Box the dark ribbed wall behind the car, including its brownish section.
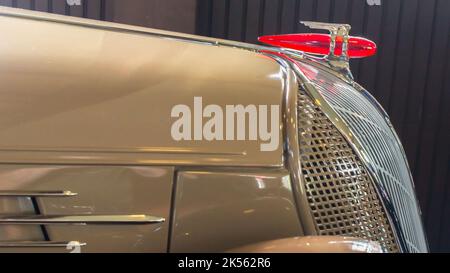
[0,0,450,252]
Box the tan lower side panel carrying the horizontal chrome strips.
[0,165,173,252]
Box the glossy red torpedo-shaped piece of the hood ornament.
[258,33,377,58]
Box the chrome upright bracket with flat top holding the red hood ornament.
[300,21,353,81]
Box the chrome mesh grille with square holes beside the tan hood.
[298,88,399,252]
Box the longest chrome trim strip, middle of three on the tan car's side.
[0,214,165,225]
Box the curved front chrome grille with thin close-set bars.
[301,61,427,252]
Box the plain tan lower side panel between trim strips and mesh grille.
[170,170,302,252]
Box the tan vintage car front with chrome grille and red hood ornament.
[0,8,428,252]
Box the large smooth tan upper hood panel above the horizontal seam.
[0,10,283,166]
